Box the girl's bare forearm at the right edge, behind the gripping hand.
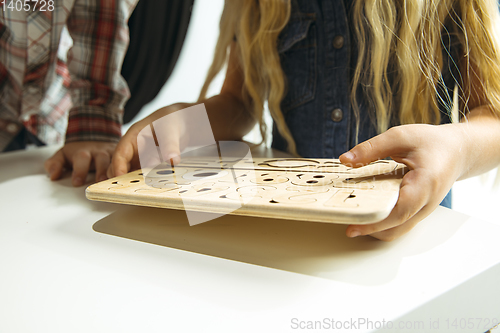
[452,107,500,180]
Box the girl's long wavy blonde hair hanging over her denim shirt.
[200,0,500,154]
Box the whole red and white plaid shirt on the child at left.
[0,0,137,151]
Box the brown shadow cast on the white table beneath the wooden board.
[93,206,468,285]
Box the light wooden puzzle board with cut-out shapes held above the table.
[86,157,405,224]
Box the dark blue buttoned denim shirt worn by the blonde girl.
[272,0,460,207]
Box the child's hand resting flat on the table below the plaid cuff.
[45,141,116,186]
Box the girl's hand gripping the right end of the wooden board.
[340,125,464,241]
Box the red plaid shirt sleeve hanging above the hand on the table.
[66,0,139,142]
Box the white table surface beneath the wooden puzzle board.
[0,147,500,333]
